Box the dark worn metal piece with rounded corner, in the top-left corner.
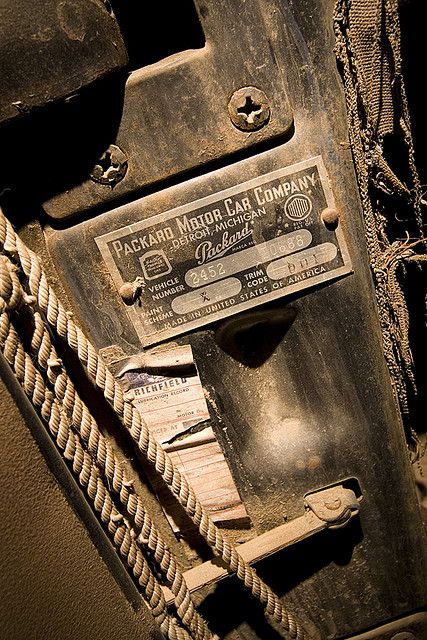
[0,0,127,122]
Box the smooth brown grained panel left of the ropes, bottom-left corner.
[0,361,159,640]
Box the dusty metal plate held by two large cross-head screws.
[40,0,293,218]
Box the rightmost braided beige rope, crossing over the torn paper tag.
[0,211,309,640]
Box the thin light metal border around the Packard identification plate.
[94,156,353,346]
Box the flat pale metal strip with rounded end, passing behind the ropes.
[163,484,361,604]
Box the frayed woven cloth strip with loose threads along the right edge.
[334,0,425,457]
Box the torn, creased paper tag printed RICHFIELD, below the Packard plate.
[114,346,249,532]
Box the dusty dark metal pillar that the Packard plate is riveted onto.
[46,0,425,638]
